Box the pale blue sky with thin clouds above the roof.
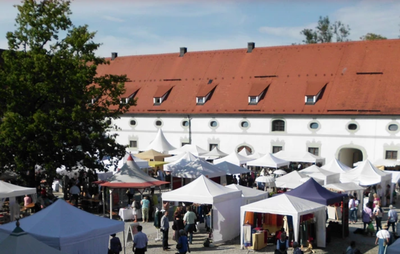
[0,0,400,57]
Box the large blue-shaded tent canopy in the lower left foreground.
[0,199,124,254]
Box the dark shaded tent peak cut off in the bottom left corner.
[0,226,66,254]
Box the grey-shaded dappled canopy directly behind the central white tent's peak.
[170,158,226,178]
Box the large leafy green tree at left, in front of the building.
[0,0,135,186]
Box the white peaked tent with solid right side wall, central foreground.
[161,176,242,242]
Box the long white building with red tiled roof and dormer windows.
[98,40,400,166]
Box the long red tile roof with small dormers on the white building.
[94,40,400,115]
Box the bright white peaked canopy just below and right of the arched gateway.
[340,160,392,187]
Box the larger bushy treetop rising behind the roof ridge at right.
[300,16,350,44]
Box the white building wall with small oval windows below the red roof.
[109,115,400,167]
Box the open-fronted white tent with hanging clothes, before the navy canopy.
[240,194,326,247]
